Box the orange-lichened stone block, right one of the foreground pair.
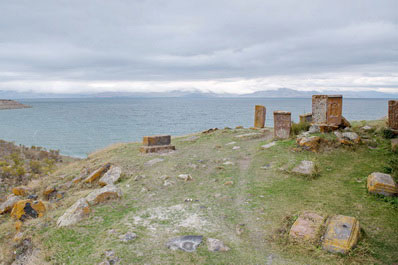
[322,215,360,254]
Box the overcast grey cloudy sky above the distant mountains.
[0,0,398,93]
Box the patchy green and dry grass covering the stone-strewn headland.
[0,122,398,264]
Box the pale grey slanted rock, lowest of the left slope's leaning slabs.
[57,198,90,227]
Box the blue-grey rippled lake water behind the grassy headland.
[0,98,388,157]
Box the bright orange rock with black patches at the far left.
[11,199,46,221]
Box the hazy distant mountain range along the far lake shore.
[0,88,398,99]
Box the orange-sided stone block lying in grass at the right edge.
[367,172,398,196]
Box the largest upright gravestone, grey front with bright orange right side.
[312,95,343,126]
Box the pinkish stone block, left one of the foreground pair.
[289,212,325,243]
